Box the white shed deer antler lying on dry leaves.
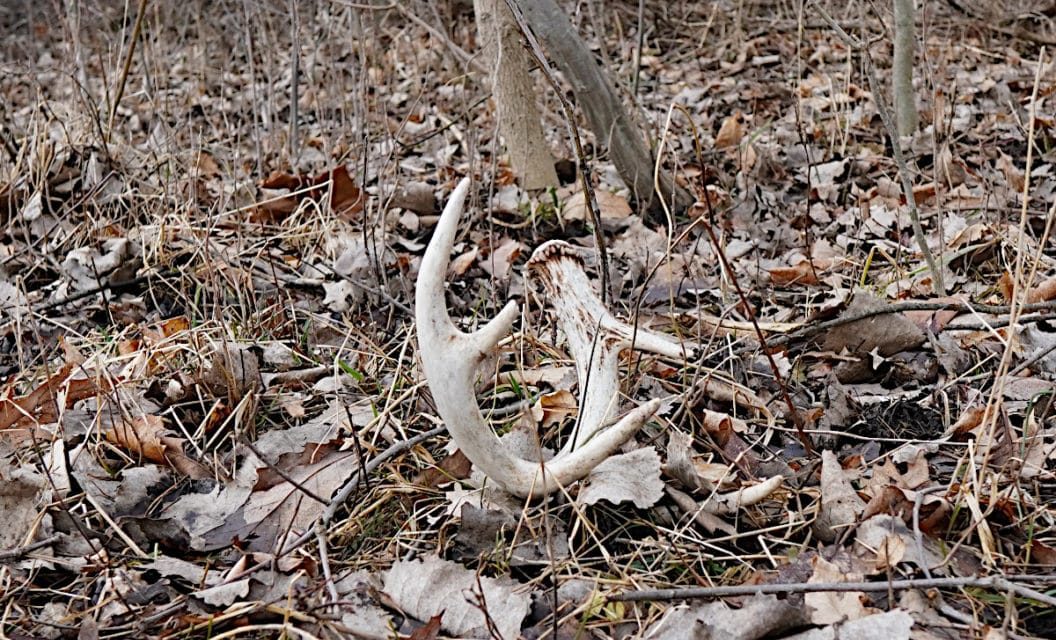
[415,178,684,497]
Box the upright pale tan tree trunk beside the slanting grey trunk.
[473,0,558,190]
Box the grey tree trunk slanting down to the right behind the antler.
[518,0,695,209]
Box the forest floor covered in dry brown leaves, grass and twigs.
[0,0,1056,640]
